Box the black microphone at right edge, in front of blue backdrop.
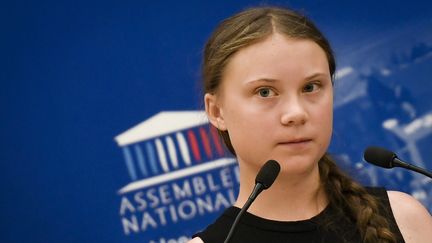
[364,146,432,179]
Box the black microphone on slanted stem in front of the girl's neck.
[224,160,280,243]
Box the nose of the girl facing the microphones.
[281,98,308,126]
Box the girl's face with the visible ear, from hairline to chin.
[205,34,333,174]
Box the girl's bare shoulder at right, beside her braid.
[387,191,432,243]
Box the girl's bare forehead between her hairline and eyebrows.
[222,33,330,86]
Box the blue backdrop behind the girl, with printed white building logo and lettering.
[0,0,432,243]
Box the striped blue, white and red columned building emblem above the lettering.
[115,111,235,194]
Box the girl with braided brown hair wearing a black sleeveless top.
[190,7,432,243]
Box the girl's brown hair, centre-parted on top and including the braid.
[202,7,395,242]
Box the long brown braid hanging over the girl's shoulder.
[320,154,396,243]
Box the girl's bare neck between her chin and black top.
[235,162,327,221]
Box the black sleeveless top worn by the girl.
[193,188,405,243]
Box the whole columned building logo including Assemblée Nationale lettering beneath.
[114,111,239,235]
